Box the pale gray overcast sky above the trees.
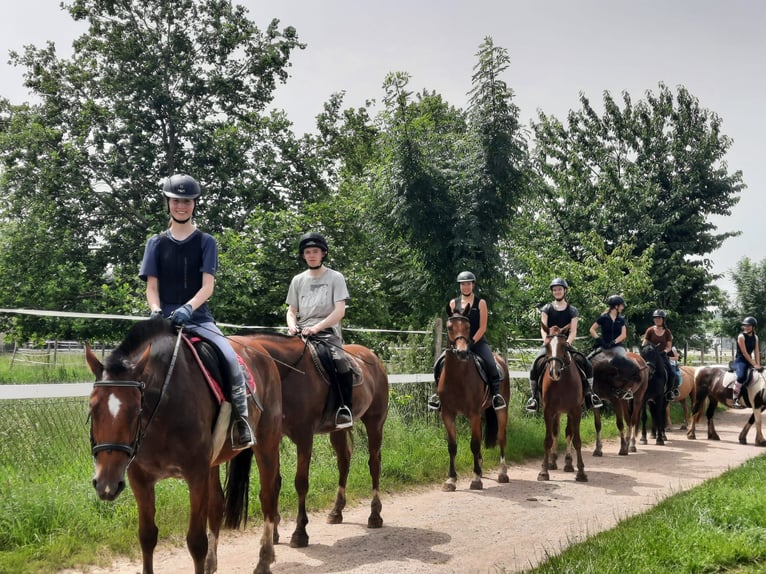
[0,0,766,294]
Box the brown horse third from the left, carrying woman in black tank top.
[436,304,511,492]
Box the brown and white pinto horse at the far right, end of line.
[686,365,766,446]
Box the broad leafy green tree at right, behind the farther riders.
[533,84,744,344]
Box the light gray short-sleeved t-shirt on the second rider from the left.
[286,268,349,338]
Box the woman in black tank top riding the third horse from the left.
[428,271,507,410]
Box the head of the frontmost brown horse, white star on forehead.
[85,321,171,500]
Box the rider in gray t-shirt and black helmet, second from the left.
[286,231,354,429]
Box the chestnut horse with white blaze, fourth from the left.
[537,325,588,482]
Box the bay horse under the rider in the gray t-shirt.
[234,332,388,548]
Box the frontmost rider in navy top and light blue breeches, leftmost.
[139,174,255,450]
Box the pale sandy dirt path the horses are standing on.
[66,411,764,574]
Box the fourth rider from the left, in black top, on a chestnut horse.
[524,277,603,412]
